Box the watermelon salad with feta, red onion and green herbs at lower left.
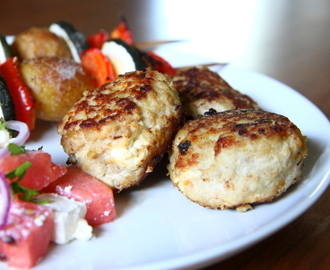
[0,118,116,269]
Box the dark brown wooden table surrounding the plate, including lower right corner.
[0,0,330,270]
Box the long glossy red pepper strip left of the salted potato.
[0,57,36,130]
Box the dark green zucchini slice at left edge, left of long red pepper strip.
[0,75,16,121]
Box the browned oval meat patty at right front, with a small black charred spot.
[168,110,307,211]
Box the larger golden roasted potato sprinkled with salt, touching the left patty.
[19,57,96,122]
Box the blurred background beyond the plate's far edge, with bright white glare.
[0,0,330,117]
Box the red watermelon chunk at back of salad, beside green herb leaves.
[0,150,66,190]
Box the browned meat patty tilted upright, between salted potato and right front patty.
[58,69,183,192]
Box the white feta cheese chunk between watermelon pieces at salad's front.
[37,193,93,244]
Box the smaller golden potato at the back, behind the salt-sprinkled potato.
[12,27,72,60]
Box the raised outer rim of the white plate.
[0,65,330,270]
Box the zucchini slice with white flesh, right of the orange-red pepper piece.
[101,39,146,76]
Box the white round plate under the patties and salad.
[0,66,330,270]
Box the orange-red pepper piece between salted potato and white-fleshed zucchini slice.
[81,48,115,86]
